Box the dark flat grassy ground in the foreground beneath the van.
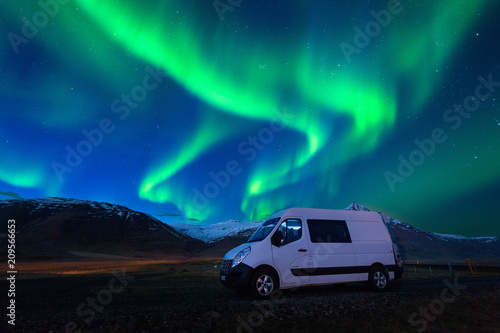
[0,260,500,332]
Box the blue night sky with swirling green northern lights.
[0,0,500,236]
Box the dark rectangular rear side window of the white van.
[307,220,351,243]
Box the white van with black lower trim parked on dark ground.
[220,208,403,298]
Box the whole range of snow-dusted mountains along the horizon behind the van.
[0,198,500,263]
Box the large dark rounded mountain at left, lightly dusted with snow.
[0,198,203,259]
